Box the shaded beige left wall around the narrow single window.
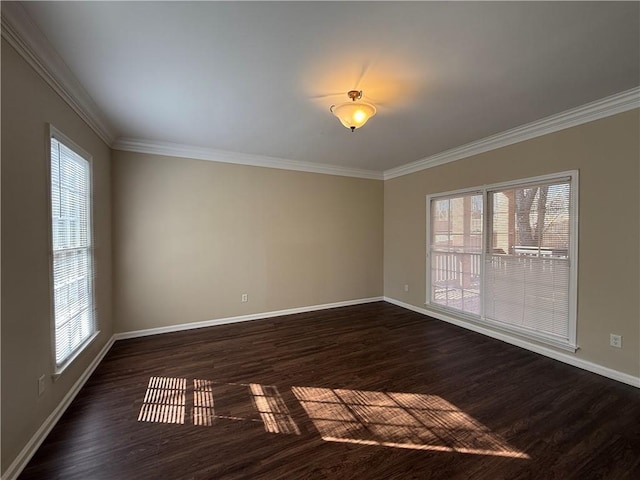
[2,40,112,472]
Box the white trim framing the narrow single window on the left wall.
[46,124,100,381]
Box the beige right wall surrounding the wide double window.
[384,110,640,377]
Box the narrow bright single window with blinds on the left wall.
[50,128,96,371]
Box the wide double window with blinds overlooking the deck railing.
[427,172,577,350]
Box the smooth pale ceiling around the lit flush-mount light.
[3,2,640,172]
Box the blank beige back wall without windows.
[113,151,383,332]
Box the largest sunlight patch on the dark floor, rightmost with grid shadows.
[291,387,529,458]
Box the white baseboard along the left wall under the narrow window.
[2,336,115,480]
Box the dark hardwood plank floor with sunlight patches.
[20,302,640,480]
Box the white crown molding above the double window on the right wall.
[383,87,640,180]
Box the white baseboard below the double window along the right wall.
[384,297,640,388]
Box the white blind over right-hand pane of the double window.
[485,181,572,341]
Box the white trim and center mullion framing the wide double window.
[425,170,579,352]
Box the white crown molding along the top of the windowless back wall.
[113,138,383,180]
